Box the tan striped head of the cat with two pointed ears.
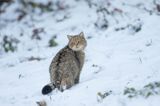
[67,32,87,51]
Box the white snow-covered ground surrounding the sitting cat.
[0,0,160,106]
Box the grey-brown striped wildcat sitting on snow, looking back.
[42,32,87,95]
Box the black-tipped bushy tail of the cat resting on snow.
[42,83,56,95]
